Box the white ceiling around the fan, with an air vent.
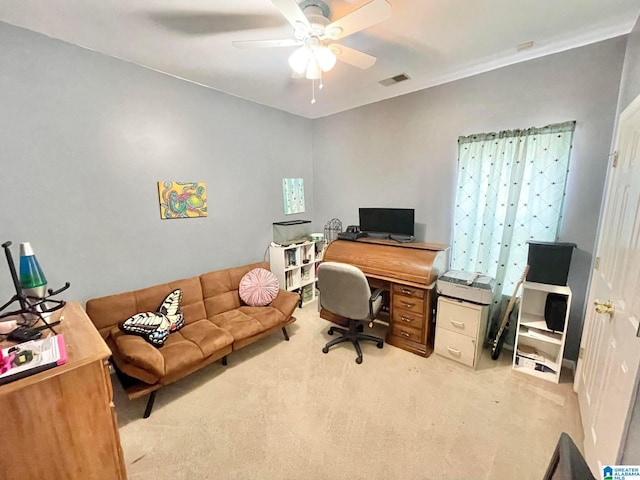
[0,0,640,118]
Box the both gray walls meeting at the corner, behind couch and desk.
[0,23,625,359]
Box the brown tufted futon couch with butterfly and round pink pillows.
[86,262,299,418]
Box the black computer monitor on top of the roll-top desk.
[359,208,415,240]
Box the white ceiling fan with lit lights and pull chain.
[232,0,391,99]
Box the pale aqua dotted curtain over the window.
[451,122,575,303]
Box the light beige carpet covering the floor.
[113,304,583,480]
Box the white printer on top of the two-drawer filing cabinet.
[436,270,496,305]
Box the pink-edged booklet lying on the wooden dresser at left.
[0,334,67,385]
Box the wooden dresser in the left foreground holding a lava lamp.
[0,303,126,480]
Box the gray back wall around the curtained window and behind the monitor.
[313,37,626,360]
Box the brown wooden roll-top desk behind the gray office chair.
[320,238,449,357]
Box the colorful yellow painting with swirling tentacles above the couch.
[158,182,207,220]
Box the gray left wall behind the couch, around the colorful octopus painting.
[0,23,313,303]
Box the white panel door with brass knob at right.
[574,97,640,478]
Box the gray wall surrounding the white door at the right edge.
[618,15,640,465]
